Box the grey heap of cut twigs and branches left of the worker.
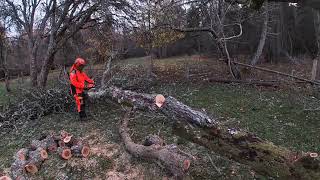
[0,87,74,132]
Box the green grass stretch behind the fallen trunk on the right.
[152,84,320,152]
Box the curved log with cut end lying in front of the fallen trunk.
[120,112,191,178]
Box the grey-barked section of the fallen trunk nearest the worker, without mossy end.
[88,86,216,127]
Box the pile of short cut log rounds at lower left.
[0,131,90,180]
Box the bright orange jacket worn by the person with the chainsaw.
[70,66,94,94]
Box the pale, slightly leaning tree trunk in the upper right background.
[251,2,269,65]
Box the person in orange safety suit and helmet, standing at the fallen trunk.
[69,58,94,120]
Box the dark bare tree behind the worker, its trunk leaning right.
[38,0,99,87]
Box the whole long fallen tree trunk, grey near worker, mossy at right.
[88,87,320,179]
